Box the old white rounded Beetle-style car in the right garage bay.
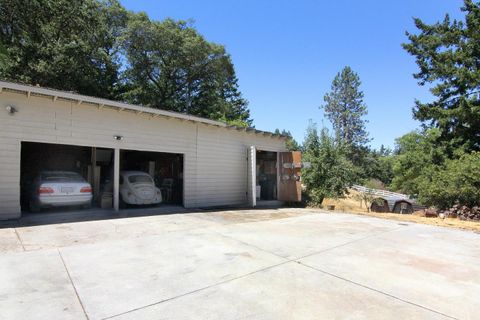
[120,171,162,205]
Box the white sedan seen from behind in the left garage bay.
[30,171,92,212]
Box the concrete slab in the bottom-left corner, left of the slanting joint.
[0,250,85,320]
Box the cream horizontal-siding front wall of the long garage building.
[0,91,285,219]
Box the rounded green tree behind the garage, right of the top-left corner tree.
[122,14,251,126]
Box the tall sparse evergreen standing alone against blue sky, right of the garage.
[321,66,369,147]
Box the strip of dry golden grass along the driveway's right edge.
[323,190,480,232]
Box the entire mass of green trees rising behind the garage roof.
[0,0,252,126]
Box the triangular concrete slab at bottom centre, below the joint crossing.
[112,262,448,320]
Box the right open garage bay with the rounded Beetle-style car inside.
[120,150,183,208]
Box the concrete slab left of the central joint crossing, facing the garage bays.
[61,230,284,319]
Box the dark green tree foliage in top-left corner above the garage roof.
[0,0,127,99]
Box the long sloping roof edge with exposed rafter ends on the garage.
[0,81,287,138]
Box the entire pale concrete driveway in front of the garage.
[0,209,480,320]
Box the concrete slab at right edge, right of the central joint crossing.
[299,224,480,319]
